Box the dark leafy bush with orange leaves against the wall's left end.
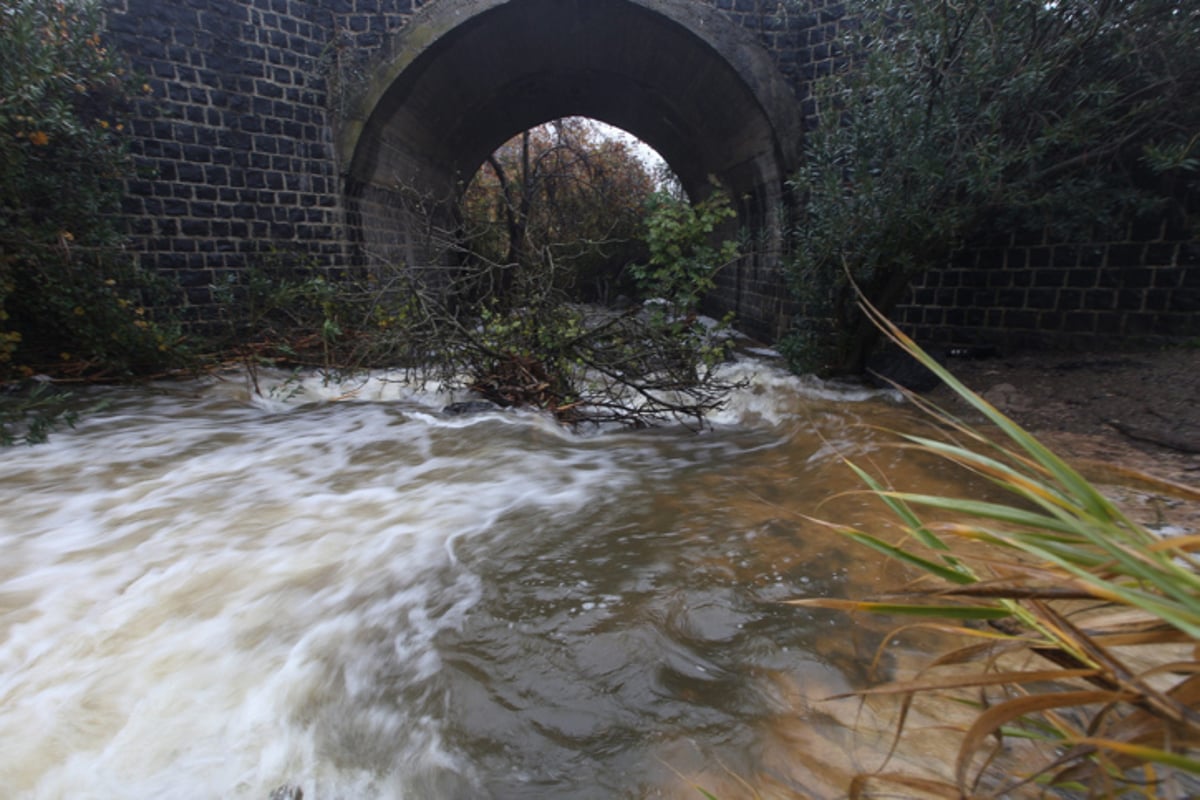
[0,0,178,378]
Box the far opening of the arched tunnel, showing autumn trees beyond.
[458,116,683,305]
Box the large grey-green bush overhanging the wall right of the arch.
[787,0,1200,373]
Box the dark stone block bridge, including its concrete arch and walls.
[106,0,1200,350]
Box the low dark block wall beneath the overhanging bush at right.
[895,221,1200,350]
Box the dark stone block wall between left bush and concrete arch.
[108,0,347,321]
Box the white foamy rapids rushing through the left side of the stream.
[0,363,912,800]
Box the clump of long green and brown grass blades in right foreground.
[792,306,1200,798]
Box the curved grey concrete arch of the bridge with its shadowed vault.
[337,0,802,284]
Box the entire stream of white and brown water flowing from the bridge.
[0,360,1012,800]
